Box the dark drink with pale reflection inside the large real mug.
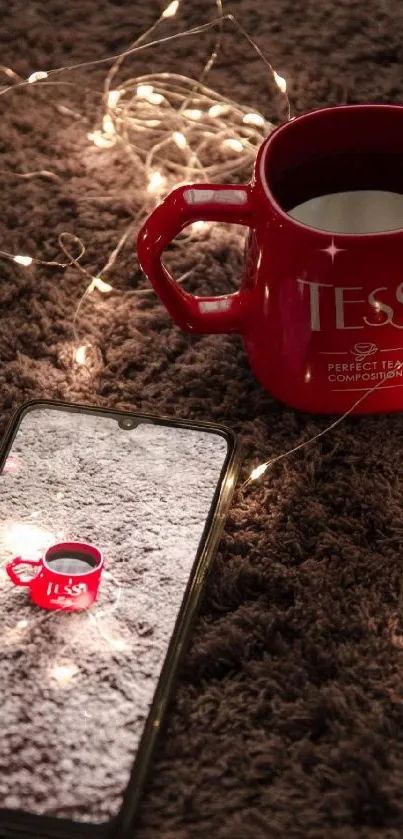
[269,153,403,233]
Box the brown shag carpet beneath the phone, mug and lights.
[0,0,403,839]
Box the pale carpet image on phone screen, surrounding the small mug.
[0,408,227,822]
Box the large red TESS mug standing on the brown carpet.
[137,105,403,413]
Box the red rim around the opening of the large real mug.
[255,103,403,242]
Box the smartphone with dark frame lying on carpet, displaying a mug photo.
[0,401,239,839]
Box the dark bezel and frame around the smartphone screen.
[0,399,241,839]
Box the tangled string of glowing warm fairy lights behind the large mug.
[0,0,290,348]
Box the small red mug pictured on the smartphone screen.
[6,542,104,612]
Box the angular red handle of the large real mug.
[137,184,254,333]
